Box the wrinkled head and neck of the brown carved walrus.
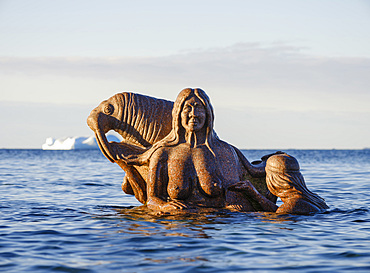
[87,92,173,162]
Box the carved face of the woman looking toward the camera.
[181,96,207,132]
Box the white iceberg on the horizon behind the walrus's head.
[42,135,120,150]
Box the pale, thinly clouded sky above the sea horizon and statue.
[0,0,370,150]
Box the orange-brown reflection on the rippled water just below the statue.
[93,203,330,239]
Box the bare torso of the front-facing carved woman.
[156,143,239,207]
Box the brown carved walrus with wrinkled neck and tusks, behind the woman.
[87,92,173,204]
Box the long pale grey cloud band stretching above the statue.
[0,44,370,92]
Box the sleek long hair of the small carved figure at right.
[266,154,329,209]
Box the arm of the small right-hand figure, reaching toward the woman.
[228,180,278,212]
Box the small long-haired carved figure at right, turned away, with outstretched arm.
[229,154,329,214]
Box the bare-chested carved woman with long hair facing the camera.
[89,88,274,212]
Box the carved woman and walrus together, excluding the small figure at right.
[88,88,276,212]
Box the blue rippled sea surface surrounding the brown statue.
[0,149,370,273]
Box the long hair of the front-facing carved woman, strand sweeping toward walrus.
[125,88,220,165]
